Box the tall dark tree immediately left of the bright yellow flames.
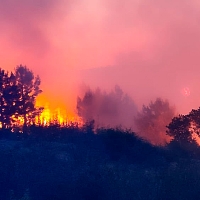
[14,65,42,128]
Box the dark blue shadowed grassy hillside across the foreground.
[0,125,200,200]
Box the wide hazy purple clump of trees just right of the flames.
[77,86,137,128]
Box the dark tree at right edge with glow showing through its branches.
[167,108,200,158]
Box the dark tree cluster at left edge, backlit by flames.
[0,65,42,128]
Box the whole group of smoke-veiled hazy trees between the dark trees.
[77,86,176,145]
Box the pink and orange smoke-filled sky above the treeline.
[0,0,200,114]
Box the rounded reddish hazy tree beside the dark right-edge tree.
[135,98,175,145]
